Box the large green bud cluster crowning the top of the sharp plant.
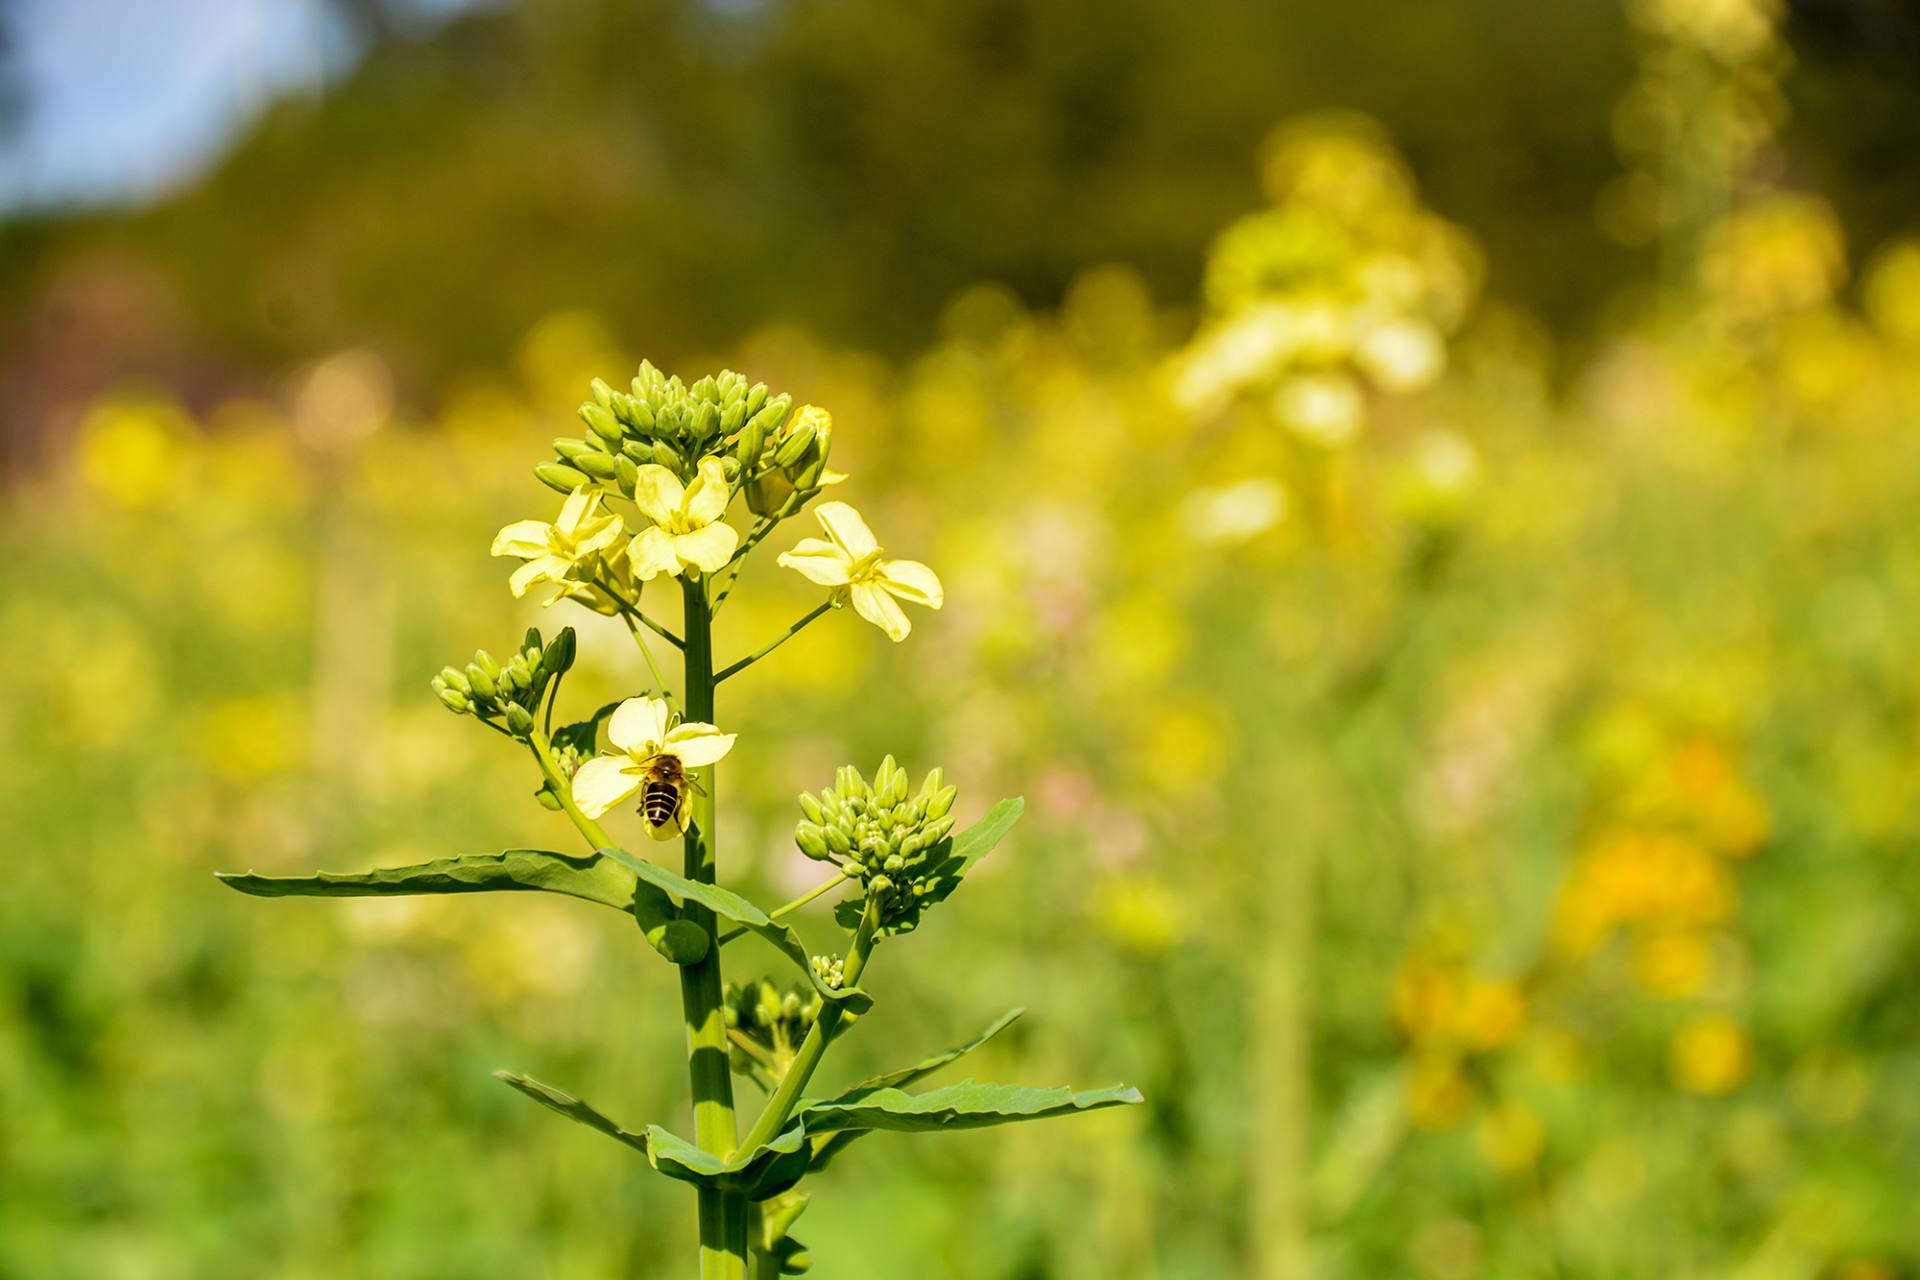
[534,361,831,516]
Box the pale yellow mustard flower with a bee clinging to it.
[574,699,733,841]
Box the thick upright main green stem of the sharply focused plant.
[680,580,747,1280]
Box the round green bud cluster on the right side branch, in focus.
[793,756,958,921]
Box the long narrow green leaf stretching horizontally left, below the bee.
[215,848,634,912]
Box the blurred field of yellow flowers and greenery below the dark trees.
[0,0,1920,1280]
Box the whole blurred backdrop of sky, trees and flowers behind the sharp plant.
[0,0,1920,1280]
